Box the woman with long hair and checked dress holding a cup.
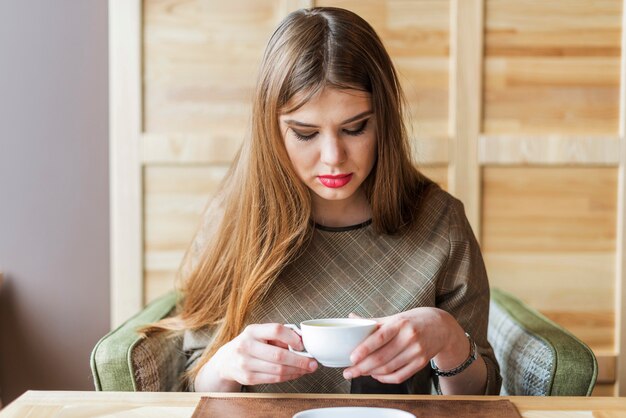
[157,8,500,394]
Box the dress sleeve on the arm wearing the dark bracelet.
[436,199,502,395]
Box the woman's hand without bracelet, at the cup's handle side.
[194,324,317,392]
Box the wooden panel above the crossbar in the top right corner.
[484,0,622,135]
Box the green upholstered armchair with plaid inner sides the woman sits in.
[91,289,598,396]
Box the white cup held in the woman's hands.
[285,318,376,367]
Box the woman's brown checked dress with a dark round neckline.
[184,183,501,394]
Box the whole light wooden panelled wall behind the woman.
[110,0,626,394]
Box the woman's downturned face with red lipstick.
[279,88,376,219]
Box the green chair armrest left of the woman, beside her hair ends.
[91,292,184,391]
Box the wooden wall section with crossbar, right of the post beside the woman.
[480,0,622,394]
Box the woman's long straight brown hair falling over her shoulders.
[153,8,420,384]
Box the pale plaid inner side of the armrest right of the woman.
[488,302,556,396]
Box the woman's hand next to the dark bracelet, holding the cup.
[343,308,470,383]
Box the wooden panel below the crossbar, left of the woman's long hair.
[144,166,227,302]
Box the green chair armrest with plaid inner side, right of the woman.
[488,289,598,396]
